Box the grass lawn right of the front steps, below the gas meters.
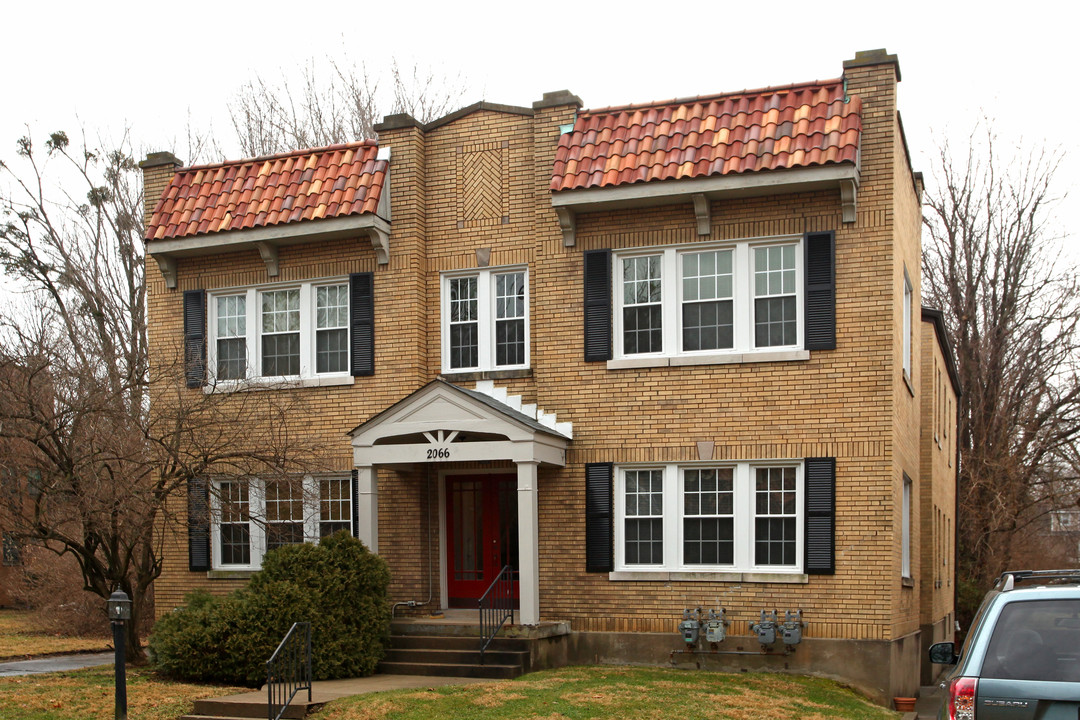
[309,666,900,720]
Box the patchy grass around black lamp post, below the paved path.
[0,665,248,720]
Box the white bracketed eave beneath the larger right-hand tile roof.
[551,163,859,247]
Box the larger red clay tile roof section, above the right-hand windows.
[551,80,862,190]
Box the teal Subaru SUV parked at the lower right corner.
[930,570,1080,720]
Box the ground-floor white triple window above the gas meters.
[615,460,805,573]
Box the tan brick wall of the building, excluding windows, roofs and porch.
[150,59,941,651]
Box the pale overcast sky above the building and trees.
[0,0,1080,255]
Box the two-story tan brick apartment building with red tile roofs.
[143,51,957,699]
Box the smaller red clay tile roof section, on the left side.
[146,140,389,240]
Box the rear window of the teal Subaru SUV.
[982,599,1080,682]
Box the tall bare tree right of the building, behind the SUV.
[922,126,1080,612]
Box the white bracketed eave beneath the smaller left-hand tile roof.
[146,213,390,288]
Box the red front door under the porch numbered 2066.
[446,475,517,608]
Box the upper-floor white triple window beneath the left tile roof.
[206,279,350,384]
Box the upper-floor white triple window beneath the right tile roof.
[612,236,804,358]
